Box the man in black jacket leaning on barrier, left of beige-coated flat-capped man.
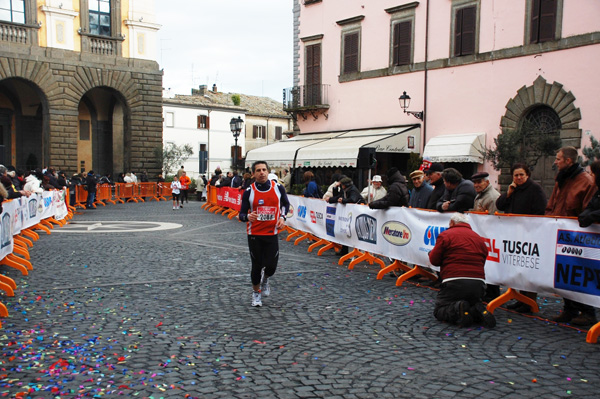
[437,168,477,212]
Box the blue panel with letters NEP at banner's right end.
[554,230,600,295]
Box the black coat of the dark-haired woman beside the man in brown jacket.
[496,178,547,215]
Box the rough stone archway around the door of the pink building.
[499,76,581,196]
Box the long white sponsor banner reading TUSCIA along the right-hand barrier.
[287,195,600,307]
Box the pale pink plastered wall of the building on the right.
[298,0,600,184]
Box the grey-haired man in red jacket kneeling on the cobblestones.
[429,213,496,327]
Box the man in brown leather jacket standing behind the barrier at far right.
[546,147,598,326]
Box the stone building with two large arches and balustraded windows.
[0,0,162,178]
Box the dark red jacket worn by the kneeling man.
[429,223,488,281]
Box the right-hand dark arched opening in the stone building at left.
[77,87,130,176]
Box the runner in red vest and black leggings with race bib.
[238,161,290,306]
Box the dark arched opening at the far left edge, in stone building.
[0,78,49,170]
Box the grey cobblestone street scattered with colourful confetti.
[0,202,600,399]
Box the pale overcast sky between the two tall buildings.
[155,0,293,102]
